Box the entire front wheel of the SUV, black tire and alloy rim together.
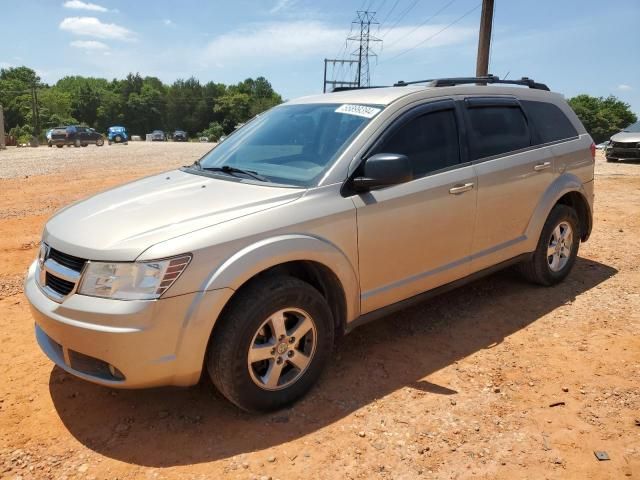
[207,276,334,411]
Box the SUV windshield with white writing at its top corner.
[194,104,382,187]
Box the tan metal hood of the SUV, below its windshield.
[43,170,305,261]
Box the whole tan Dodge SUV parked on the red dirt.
[25,77,595,411]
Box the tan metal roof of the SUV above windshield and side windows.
[287,84,562,105]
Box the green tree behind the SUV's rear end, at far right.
[569,94,637,143]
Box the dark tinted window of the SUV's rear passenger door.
[467,105,531,160]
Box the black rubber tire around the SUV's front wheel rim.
[207,276,334,412]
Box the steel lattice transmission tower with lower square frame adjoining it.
[323,10,382,92]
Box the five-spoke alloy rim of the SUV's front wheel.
[247,308,318,390]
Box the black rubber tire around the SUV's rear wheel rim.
[520,205,581,286]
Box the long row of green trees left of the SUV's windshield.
[0,66,282,141]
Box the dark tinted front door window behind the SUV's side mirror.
[378,110,460,177]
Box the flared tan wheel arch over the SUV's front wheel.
[201,234,360,322]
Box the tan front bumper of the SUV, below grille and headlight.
[25,263,233,388]
